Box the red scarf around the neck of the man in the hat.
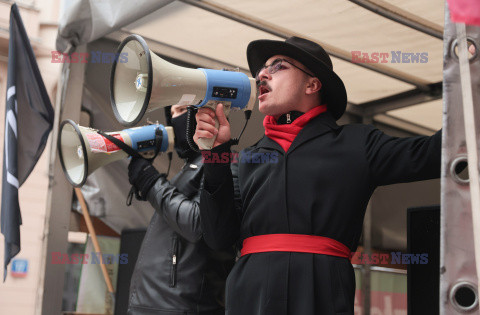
[263,105,327,152]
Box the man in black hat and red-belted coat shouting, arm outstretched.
[194,37,441,315]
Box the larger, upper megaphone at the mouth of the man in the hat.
[110,35,257,149]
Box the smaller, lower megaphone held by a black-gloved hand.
[58,120,174,187]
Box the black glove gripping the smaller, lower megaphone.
[128,157,165,200]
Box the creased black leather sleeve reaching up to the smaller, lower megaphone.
[147,176,202,243]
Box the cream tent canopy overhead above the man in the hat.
[57,0,444,133]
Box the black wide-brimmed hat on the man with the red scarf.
[247,36,347,119]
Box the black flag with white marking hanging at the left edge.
[1,4,54,281]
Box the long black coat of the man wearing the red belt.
[200,112,441,315]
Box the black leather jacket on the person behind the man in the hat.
[128,156,235,315]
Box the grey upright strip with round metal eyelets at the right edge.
[439,4,480,315]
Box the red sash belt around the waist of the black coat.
[241,234,350,259]
